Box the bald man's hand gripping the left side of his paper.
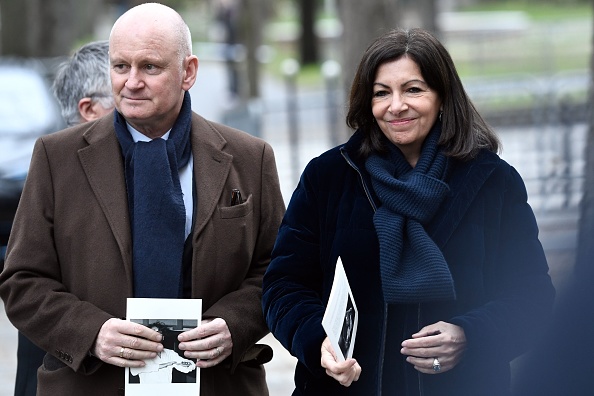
[91,318,163,367]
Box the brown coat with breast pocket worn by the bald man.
[0,114,284,396]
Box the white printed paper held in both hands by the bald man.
[125,298,202,396]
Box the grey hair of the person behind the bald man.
[52,40,114,126]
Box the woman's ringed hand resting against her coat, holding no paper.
[400,322,466,374]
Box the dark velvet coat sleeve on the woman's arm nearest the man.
[263,159,333,376]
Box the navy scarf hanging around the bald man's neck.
[114,92,192,298]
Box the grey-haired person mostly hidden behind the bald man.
[10,40,114,396]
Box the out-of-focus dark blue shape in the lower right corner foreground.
[514,226,594,396]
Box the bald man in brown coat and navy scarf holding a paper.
[0,3,284,396]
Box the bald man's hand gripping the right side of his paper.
[178,318,233,368]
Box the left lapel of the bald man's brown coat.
[78,117,133,290]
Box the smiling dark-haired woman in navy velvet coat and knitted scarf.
[263,29,555,396]
